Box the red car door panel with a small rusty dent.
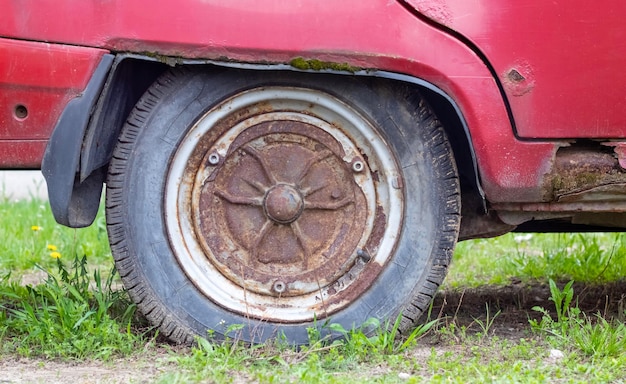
[399,0,626,139]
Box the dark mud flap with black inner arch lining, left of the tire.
[41,54,167,228]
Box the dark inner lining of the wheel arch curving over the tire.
[51,54,486,227]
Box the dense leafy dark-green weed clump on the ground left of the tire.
[0,256,142,359]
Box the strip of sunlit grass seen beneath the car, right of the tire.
[444,233,626,288]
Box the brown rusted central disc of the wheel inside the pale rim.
[194,121,368,296]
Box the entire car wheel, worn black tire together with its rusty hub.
[106,68,460,344]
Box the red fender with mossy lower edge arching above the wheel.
[0,0,559,225]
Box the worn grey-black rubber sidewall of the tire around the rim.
[111,70,451,344]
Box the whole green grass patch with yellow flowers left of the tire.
[0,200,145,359]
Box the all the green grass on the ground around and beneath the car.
[0,196,626,383]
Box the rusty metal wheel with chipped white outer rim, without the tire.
[166,88,402,322]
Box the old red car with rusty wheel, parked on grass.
[0,0,626,344]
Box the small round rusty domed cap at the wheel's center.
[263,184,304,224]
